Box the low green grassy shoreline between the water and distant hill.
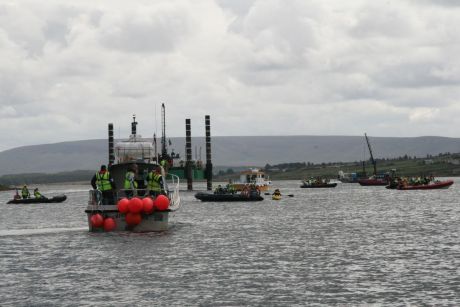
[0,153,460,184]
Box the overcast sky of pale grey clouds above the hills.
[0,0,460,151]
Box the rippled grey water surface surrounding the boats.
[0,180,460,306]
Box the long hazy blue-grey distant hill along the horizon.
[0,136,460,175]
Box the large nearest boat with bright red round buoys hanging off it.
[85,115,180,232]
